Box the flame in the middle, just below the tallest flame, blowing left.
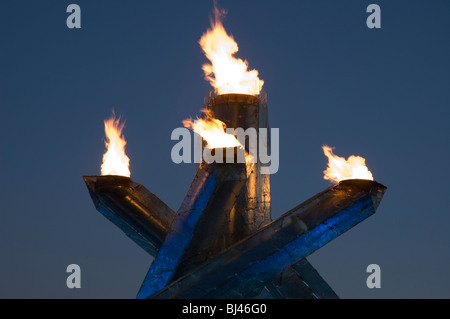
[183,109,243,148]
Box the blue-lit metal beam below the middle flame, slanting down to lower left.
[137,154,247,299]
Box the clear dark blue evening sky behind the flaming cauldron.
[0,0,450,298]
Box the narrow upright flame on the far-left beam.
[101,115,131,177]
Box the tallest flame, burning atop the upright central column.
[199,7,264,95]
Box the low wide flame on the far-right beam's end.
[322,145,373,182]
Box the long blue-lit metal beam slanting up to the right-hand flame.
[151,180,386,298]
